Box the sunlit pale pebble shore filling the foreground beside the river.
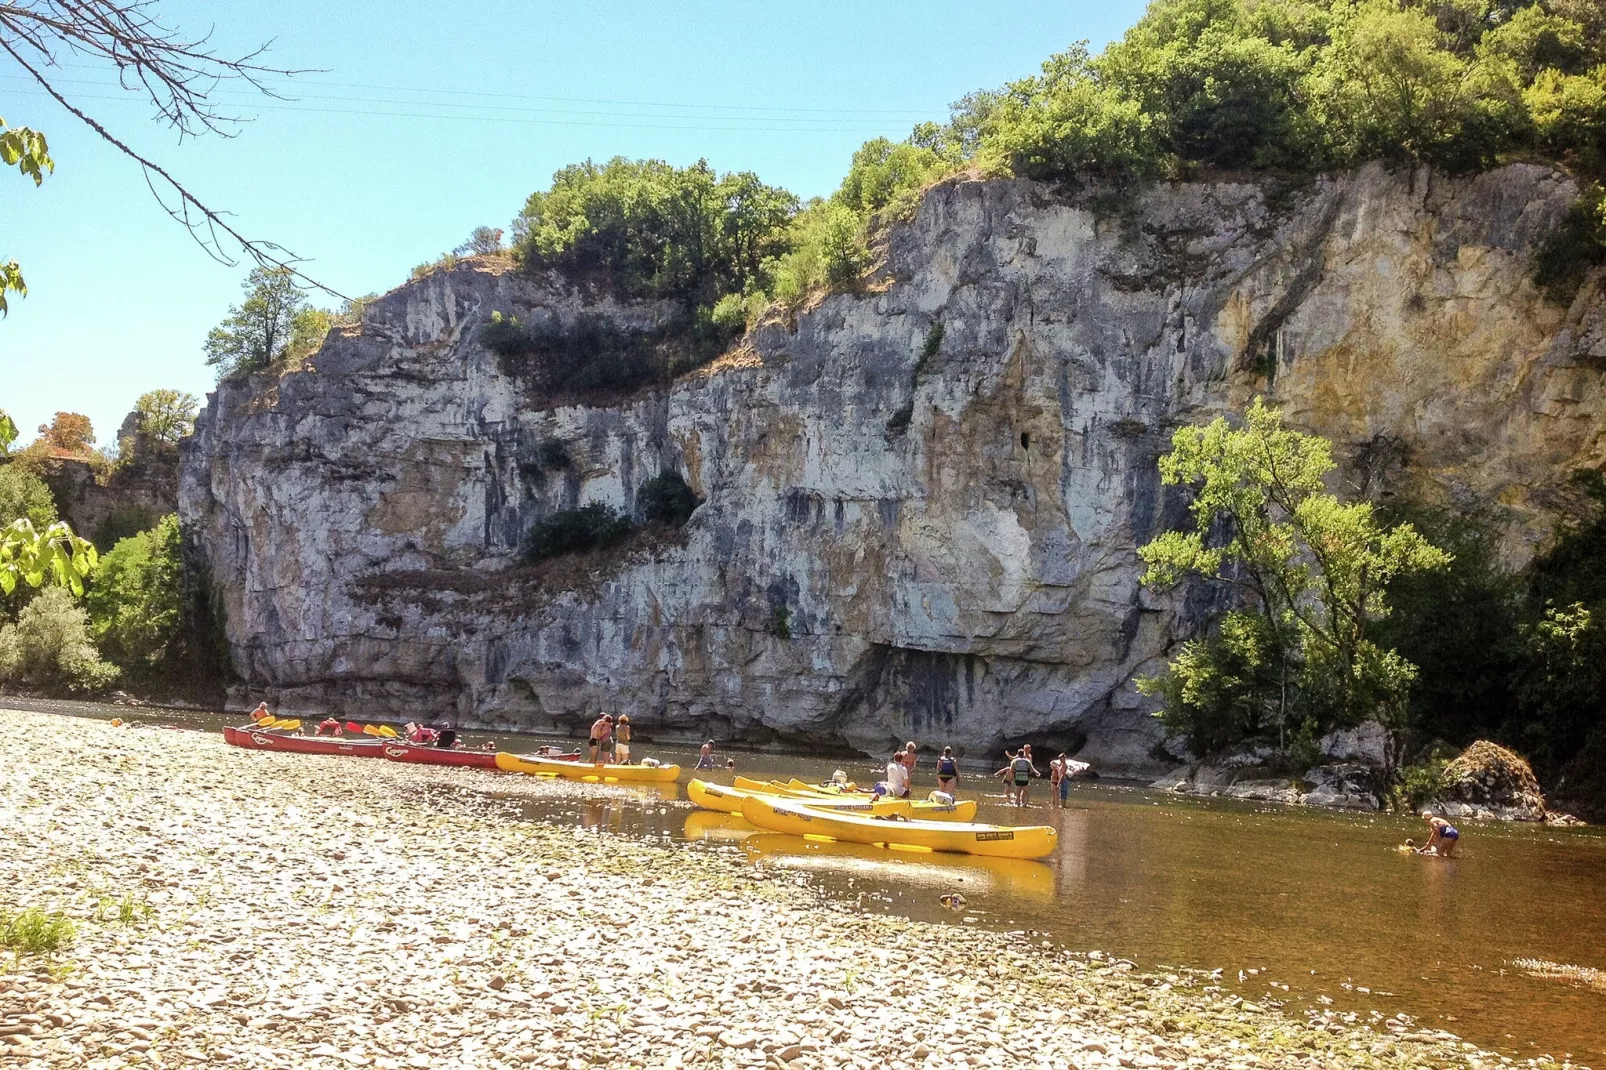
[0,710,1535,1070]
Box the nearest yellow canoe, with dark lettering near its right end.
[742,795,1058,858]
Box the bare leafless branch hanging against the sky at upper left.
[0,0,345,299]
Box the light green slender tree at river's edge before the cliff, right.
[1139,398,1450,755]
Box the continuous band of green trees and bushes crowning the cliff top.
[481,0,1606,328]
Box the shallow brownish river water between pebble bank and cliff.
[15,699,1606,1067]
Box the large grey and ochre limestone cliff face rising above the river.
[180,165,1606,771]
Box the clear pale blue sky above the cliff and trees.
[0,0,1142,443]
